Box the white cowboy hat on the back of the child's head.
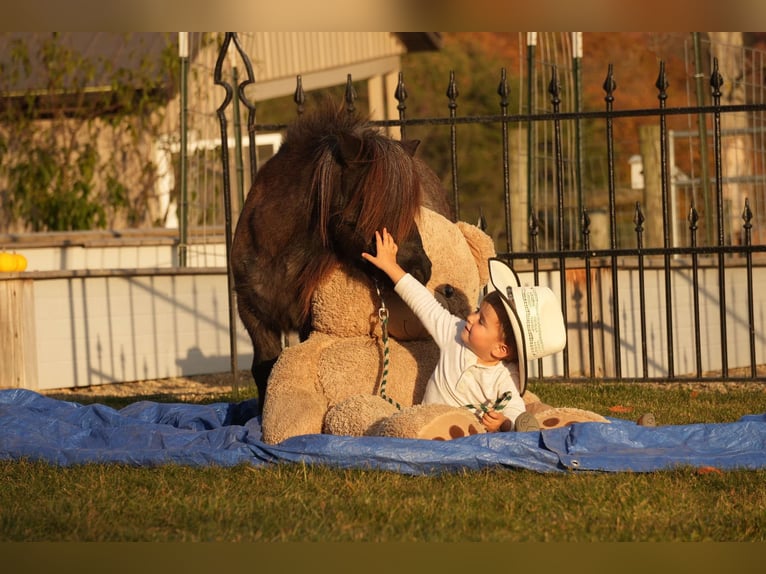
[487,257,567,395]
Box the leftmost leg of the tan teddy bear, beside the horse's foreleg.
[262,336,330,444]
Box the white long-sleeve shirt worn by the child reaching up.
[395,273,525,422]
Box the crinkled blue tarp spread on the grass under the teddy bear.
[0,389,766,474]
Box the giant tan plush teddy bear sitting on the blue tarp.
[262,207,608,444]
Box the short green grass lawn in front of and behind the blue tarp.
[0,384,766,542]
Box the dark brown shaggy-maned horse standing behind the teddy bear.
[231,104,450,408]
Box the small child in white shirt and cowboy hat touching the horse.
[362,228,566,432]
